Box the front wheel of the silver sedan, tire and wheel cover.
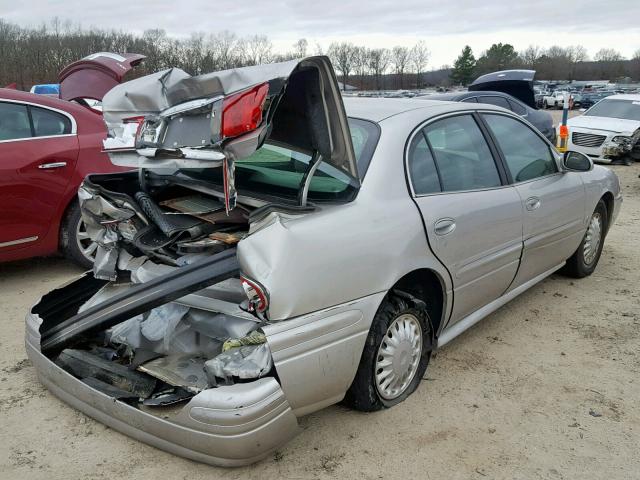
[561,200,608,278]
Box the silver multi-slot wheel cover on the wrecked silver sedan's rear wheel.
[375,313,422,400]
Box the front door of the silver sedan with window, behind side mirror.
[482,112,585,288]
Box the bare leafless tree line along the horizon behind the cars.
[0,18,640,90]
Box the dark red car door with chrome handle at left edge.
[0,101,78,254]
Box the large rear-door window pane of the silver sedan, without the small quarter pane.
[424,115,501,192]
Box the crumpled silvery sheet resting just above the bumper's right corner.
[204,343,273,382]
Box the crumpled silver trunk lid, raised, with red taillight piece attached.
[103,56,358,196]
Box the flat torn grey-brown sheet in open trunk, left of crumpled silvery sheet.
[138,355,209,393]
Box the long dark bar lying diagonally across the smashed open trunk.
[41,248,240,353]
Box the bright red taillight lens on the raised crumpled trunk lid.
[221,83,269,138]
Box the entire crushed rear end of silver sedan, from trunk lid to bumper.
[26,57,358,466]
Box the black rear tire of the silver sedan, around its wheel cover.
[344,291,434,412]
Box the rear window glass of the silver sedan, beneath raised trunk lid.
[181,118,380,201]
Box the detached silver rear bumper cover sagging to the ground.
[25,313,299,466]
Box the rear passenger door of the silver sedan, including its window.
[407,113,522,325]
